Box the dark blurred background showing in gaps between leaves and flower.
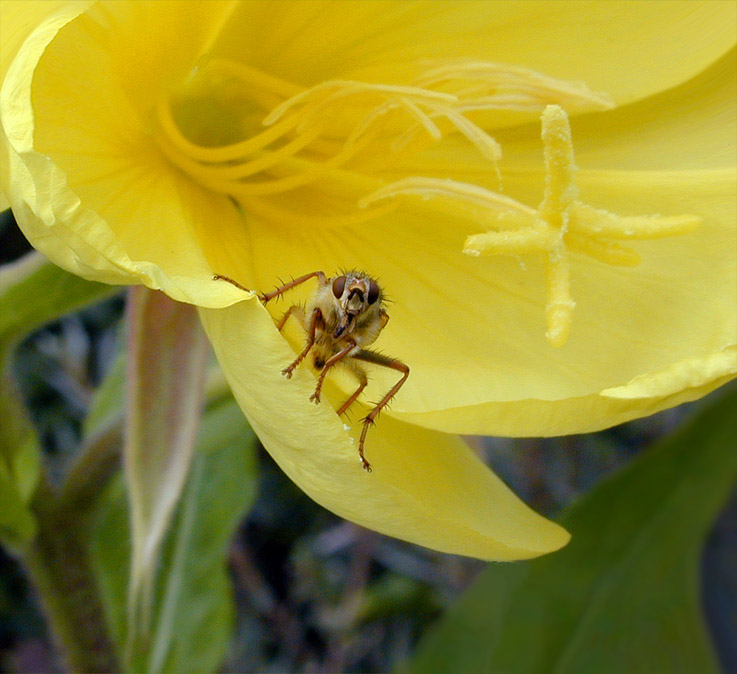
[0,211,737,673]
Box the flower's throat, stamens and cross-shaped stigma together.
[156,59,699,346]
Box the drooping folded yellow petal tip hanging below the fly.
[200,301,568,560]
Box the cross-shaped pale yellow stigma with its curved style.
[360,105,700,346]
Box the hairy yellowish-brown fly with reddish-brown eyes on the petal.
[214,271,409,473]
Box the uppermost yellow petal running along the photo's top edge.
[208,0,737,103]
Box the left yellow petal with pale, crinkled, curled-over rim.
[0,3,249,306]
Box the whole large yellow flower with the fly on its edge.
[0,0,737,559]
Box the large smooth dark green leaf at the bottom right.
[402,389,737,674]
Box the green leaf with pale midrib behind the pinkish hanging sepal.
[92,398,257,673]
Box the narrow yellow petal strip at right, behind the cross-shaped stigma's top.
[488,49,737,173]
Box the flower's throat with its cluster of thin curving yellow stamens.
[155,59,611,217]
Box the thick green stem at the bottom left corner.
[23,475,119,672]
